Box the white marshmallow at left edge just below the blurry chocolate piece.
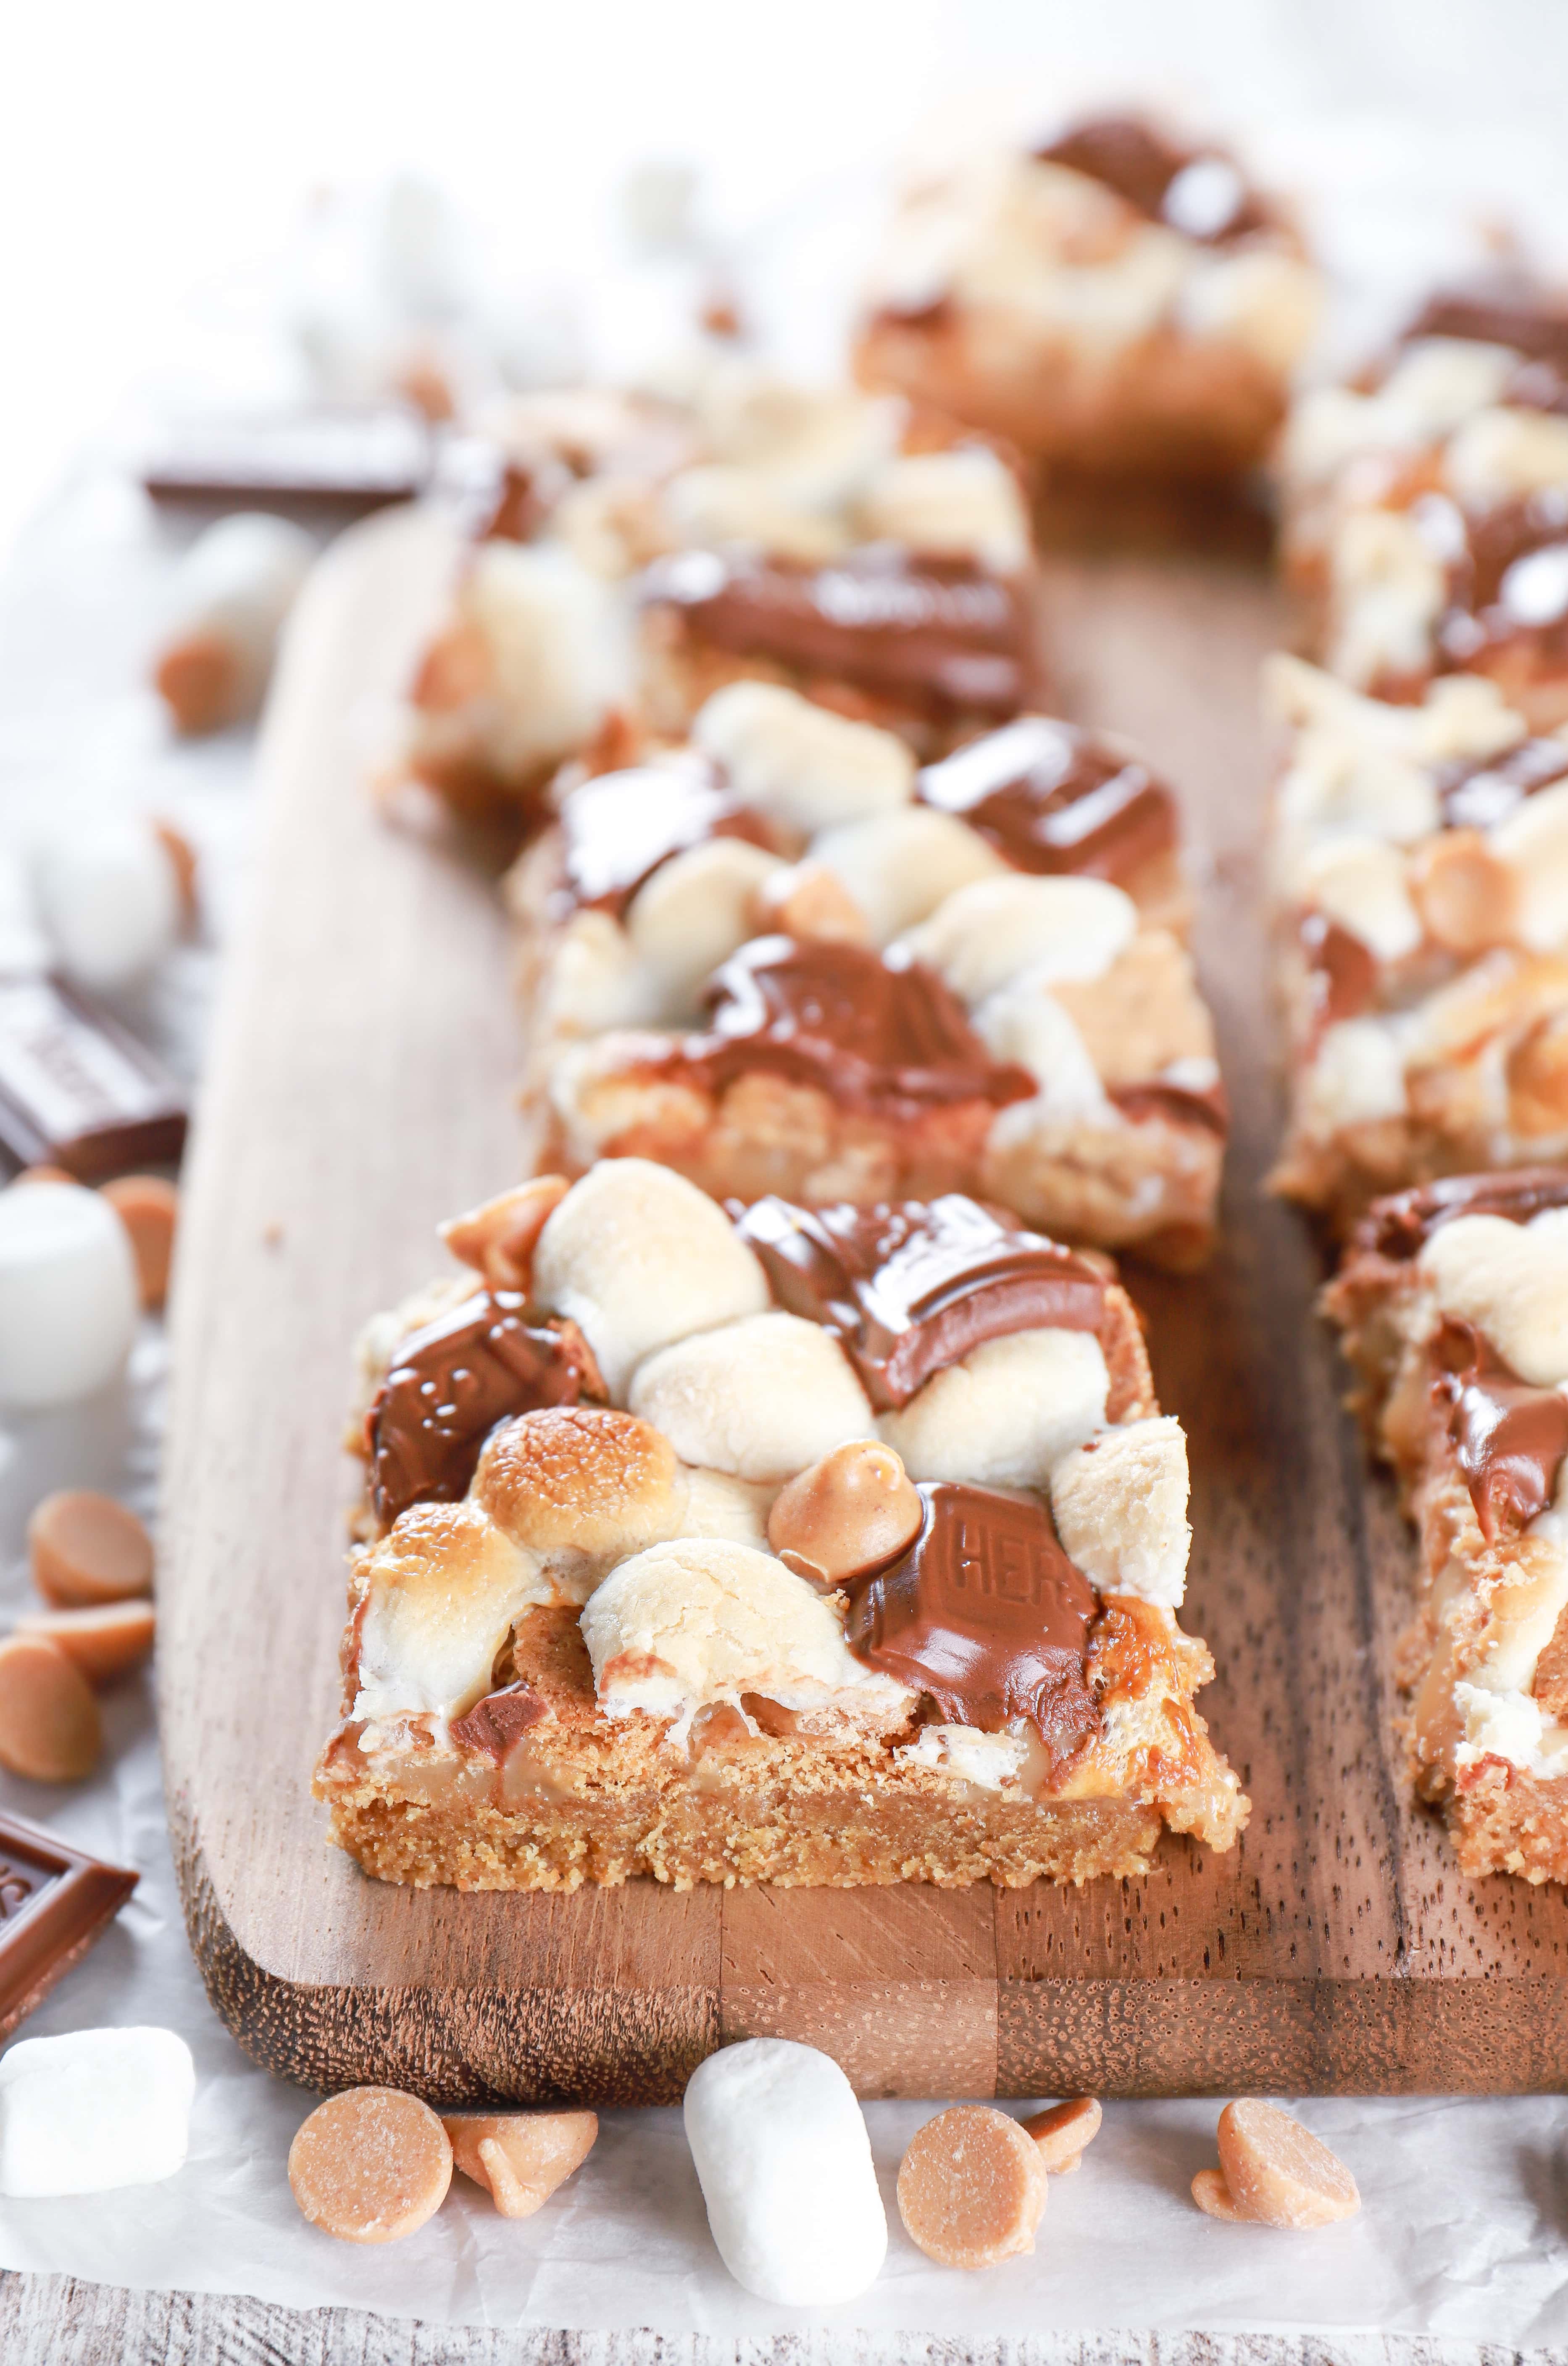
[0,1183,139,1410]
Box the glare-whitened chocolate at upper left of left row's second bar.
[556,750,771,920]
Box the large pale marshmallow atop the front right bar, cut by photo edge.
[1419,1207,1568,1389]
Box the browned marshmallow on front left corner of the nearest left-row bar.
[353,1503,556,1720]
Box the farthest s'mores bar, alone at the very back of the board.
[856,116,1320,478]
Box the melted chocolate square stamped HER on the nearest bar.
[845,1481,1100,1777]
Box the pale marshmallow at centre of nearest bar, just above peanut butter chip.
[629,1311,875,1481]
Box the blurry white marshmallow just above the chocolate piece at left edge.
[33,821,180,994]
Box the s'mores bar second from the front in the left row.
[513,684,1227,1266]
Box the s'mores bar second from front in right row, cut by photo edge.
[1268,658,1568,1226]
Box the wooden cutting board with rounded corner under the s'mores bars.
[158,513,1568,2103]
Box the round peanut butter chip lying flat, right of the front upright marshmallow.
[899,2103,1045,2266]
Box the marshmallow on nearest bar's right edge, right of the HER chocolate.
[1050,1413,1192,1611]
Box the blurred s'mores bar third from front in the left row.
[407,364,1038,826]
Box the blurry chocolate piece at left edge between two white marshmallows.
[0,977,184,1183]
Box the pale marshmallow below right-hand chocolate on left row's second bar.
[901,871,1138,1005]
